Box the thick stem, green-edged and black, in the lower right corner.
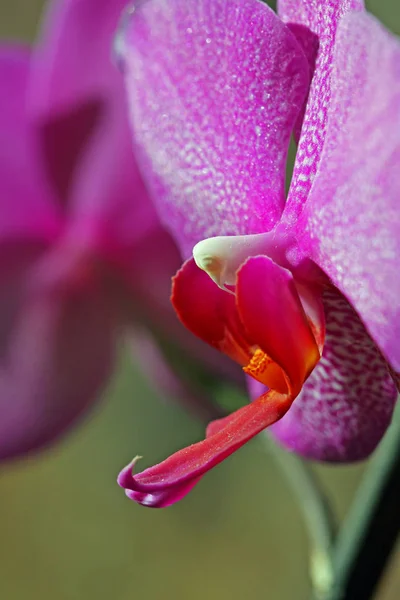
[328,410,400,600]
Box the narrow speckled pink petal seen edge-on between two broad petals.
[278,0,364,222]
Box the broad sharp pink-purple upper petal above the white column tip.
[119,0,309,256]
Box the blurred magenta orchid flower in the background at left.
[0,0,239,458]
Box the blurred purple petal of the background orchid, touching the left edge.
[0,45,59,241]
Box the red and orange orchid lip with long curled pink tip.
[118,256,323,507]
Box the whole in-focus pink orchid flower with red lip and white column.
[118,0,400,507]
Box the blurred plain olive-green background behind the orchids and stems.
[0,0,400,600]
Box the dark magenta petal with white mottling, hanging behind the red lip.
[252,290,397,462]
